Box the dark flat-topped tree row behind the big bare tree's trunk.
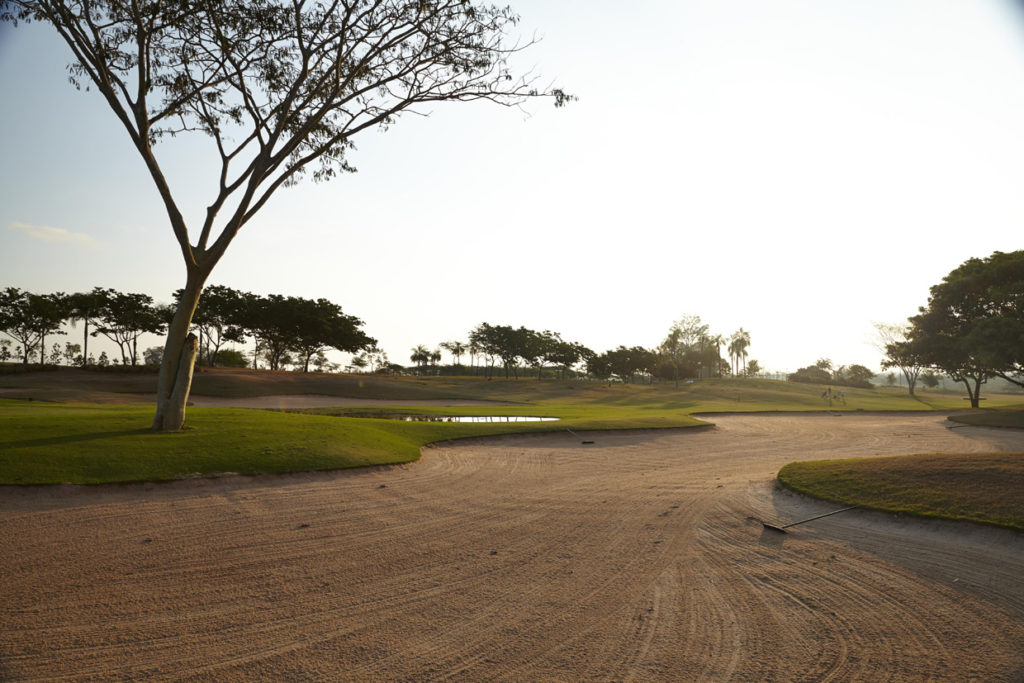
[0,286,376,372]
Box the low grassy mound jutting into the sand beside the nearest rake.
[778,453,1024,531]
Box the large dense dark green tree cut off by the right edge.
[908,251,1024,408]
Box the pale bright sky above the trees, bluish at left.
[0,0,1024,372]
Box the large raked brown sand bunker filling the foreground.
[0,415,1024,682]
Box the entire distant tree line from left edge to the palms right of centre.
[0,286,760,384]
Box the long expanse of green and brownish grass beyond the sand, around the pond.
[0,371,1020,484]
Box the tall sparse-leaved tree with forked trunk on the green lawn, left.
[0,0,571,430]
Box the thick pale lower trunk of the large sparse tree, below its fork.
[153,269,209,431]
